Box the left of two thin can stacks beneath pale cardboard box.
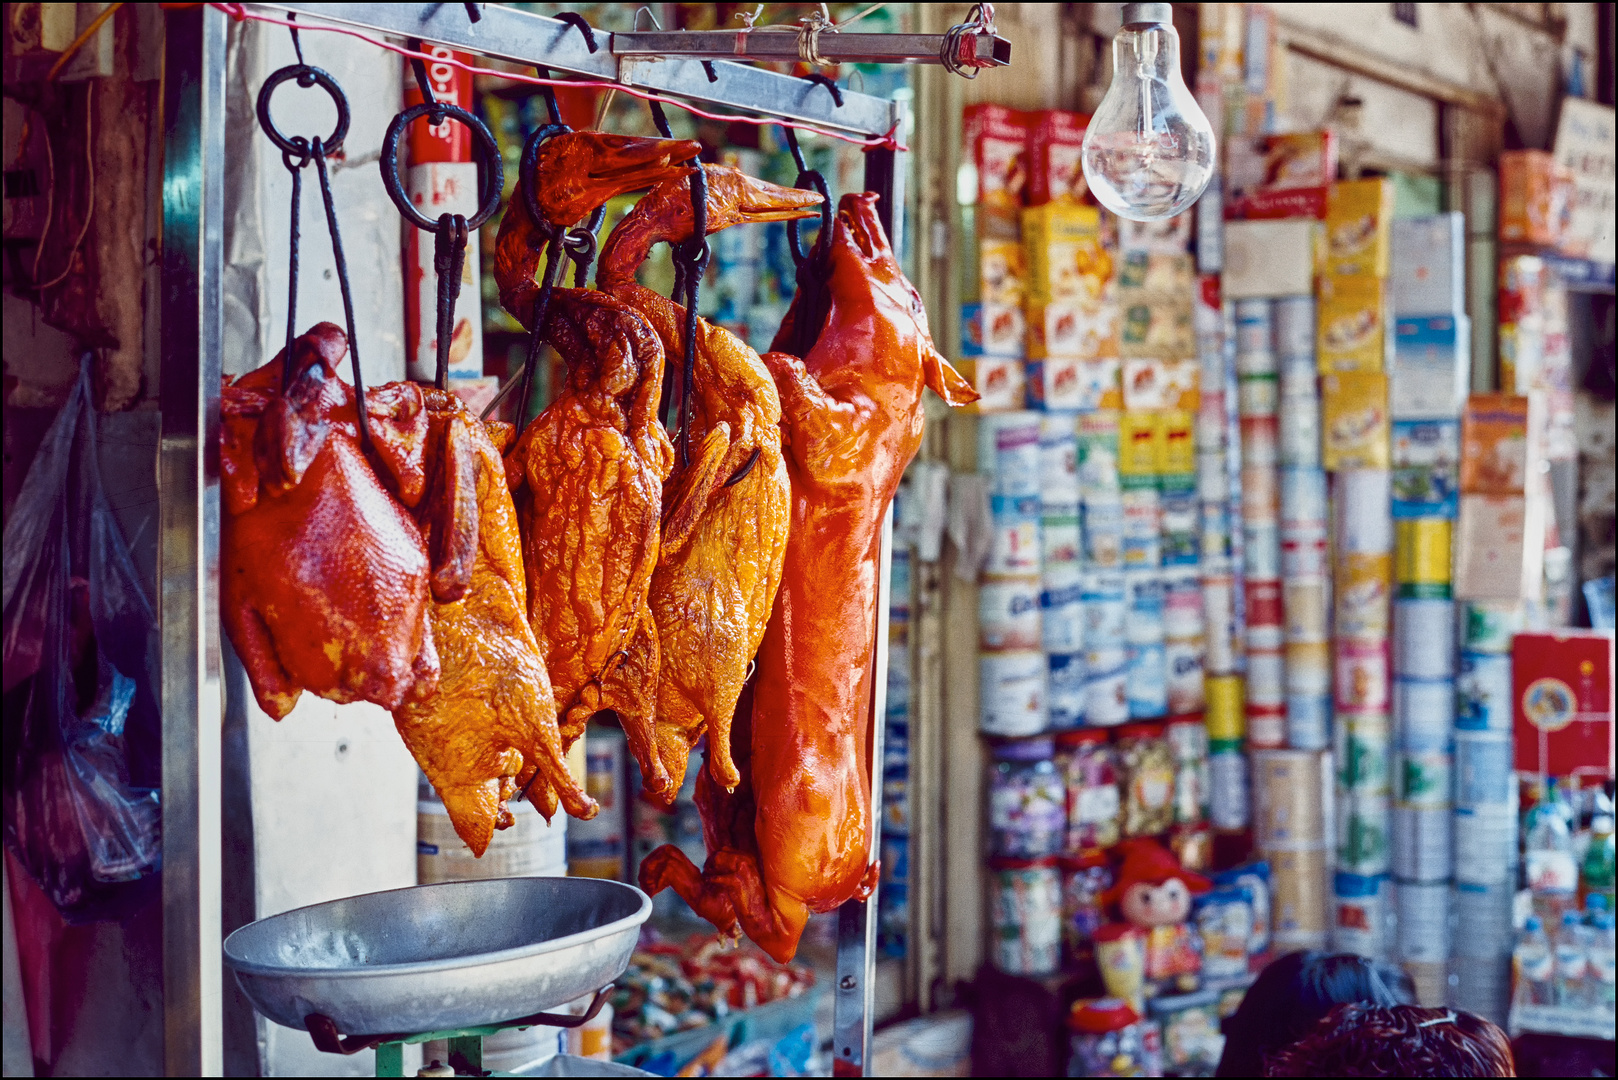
[1236,300,1286,748]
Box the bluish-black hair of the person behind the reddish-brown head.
[1214,952,1416,1077]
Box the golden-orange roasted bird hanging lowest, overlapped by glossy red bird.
[393,389,597,855]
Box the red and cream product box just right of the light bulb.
[1225,131,1336,219]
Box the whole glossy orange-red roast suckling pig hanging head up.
[641,193,977,960]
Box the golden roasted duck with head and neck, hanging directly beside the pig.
[595,165,820,801]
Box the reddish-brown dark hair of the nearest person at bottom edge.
[1264,1002,1516,1077]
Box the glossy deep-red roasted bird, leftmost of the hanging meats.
[220,322,443,721]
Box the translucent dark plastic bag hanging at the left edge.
[3,358,162,921]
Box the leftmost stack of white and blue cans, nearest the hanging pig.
[977,413,1048,735]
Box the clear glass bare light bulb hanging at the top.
[1084,3,1214,222]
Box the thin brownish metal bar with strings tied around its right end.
[612,29,1011,66]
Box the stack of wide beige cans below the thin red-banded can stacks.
[1252,750,1332,952]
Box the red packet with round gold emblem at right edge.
[1511,630,1613,776]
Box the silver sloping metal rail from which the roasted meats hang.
[254,3,916,134]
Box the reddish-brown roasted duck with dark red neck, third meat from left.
[495,133,701,799]
